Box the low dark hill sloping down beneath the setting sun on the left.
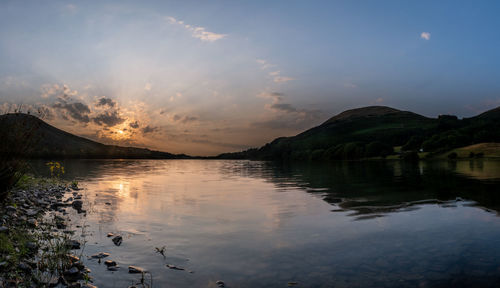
[0,113,188,159]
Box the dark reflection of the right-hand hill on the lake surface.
[222,161,500,219]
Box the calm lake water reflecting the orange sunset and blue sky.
[35,160,500,287]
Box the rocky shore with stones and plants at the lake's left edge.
[0,177,96,288]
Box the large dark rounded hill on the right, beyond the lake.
[218,106,500,160]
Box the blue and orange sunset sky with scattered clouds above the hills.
[0,0,500,155]
